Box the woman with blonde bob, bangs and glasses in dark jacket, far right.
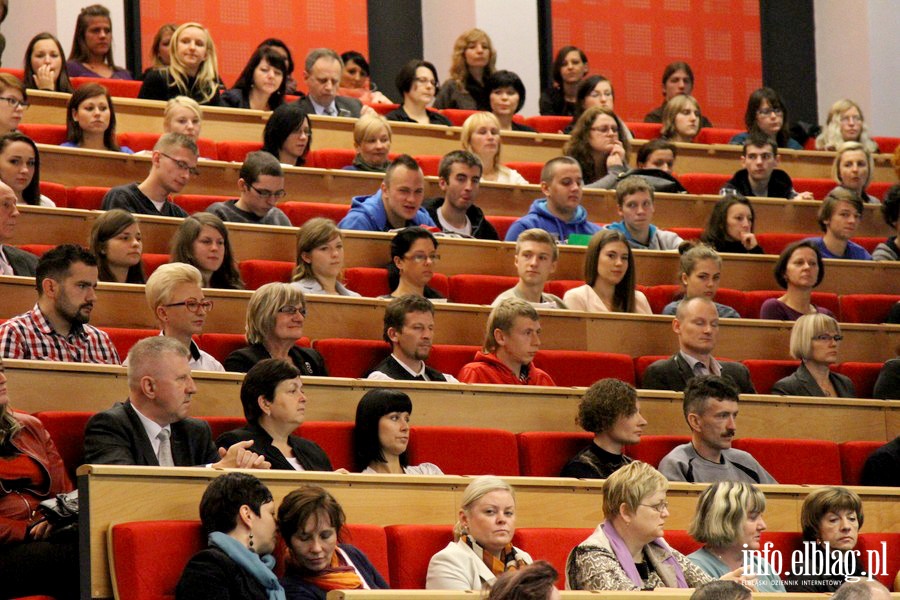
[772,313,856,398]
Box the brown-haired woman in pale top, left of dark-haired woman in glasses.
[291,217,359,298]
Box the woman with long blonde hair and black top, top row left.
[138,22,222,106]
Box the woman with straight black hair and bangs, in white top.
[353,388,444,475]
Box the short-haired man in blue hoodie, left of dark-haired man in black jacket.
[338,154,435,231]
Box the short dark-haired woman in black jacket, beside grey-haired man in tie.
[216,357,332,471]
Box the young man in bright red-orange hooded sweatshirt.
[459,298,556,385]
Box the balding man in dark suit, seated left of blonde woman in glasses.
[641,296,756,394]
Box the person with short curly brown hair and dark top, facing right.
[559,379,647,479]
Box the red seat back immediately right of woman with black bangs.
[409,426,519,475]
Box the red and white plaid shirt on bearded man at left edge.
[0,304,121,365]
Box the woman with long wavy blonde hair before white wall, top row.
[434,28,497,111]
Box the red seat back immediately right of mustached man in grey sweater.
[732,438,842,485]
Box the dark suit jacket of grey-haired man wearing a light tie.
[84,401,219,467]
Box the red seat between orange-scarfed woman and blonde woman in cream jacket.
[384,525,453,590]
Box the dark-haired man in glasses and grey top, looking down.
[206,151,291,227]
